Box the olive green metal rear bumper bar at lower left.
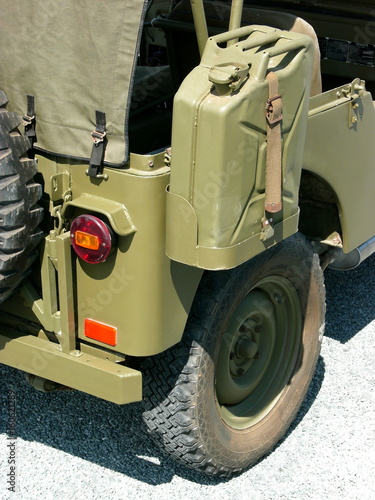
[0,330,142,404]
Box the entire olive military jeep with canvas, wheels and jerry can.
[0,0,375,476]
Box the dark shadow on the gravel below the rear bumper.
[0,365,222,485]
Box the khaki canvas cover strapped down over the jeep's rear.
[0,0,146,165]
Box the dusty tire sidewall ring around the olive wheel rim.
[192,236,324,468]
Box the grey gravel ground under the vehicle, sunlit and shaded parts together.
[0,256,375,500]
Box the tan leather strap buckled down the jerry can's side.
[265,72,283,213]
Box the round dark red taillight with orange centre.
[70,215,113,264]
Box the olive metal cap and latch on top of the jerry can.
[208,63,249,95]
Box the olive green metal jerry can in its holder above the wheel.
[167,26,313,269]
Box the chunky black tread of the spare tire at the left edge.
[0,92,43,302]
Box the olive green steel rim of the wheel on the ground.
[215,276,302,429]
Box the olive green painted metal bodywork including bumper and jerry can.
[0,2,375,404]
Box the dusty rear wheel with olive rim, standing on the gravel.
[143,235,325,476]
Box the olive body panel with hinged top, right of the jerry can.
[304,81,375,253]
